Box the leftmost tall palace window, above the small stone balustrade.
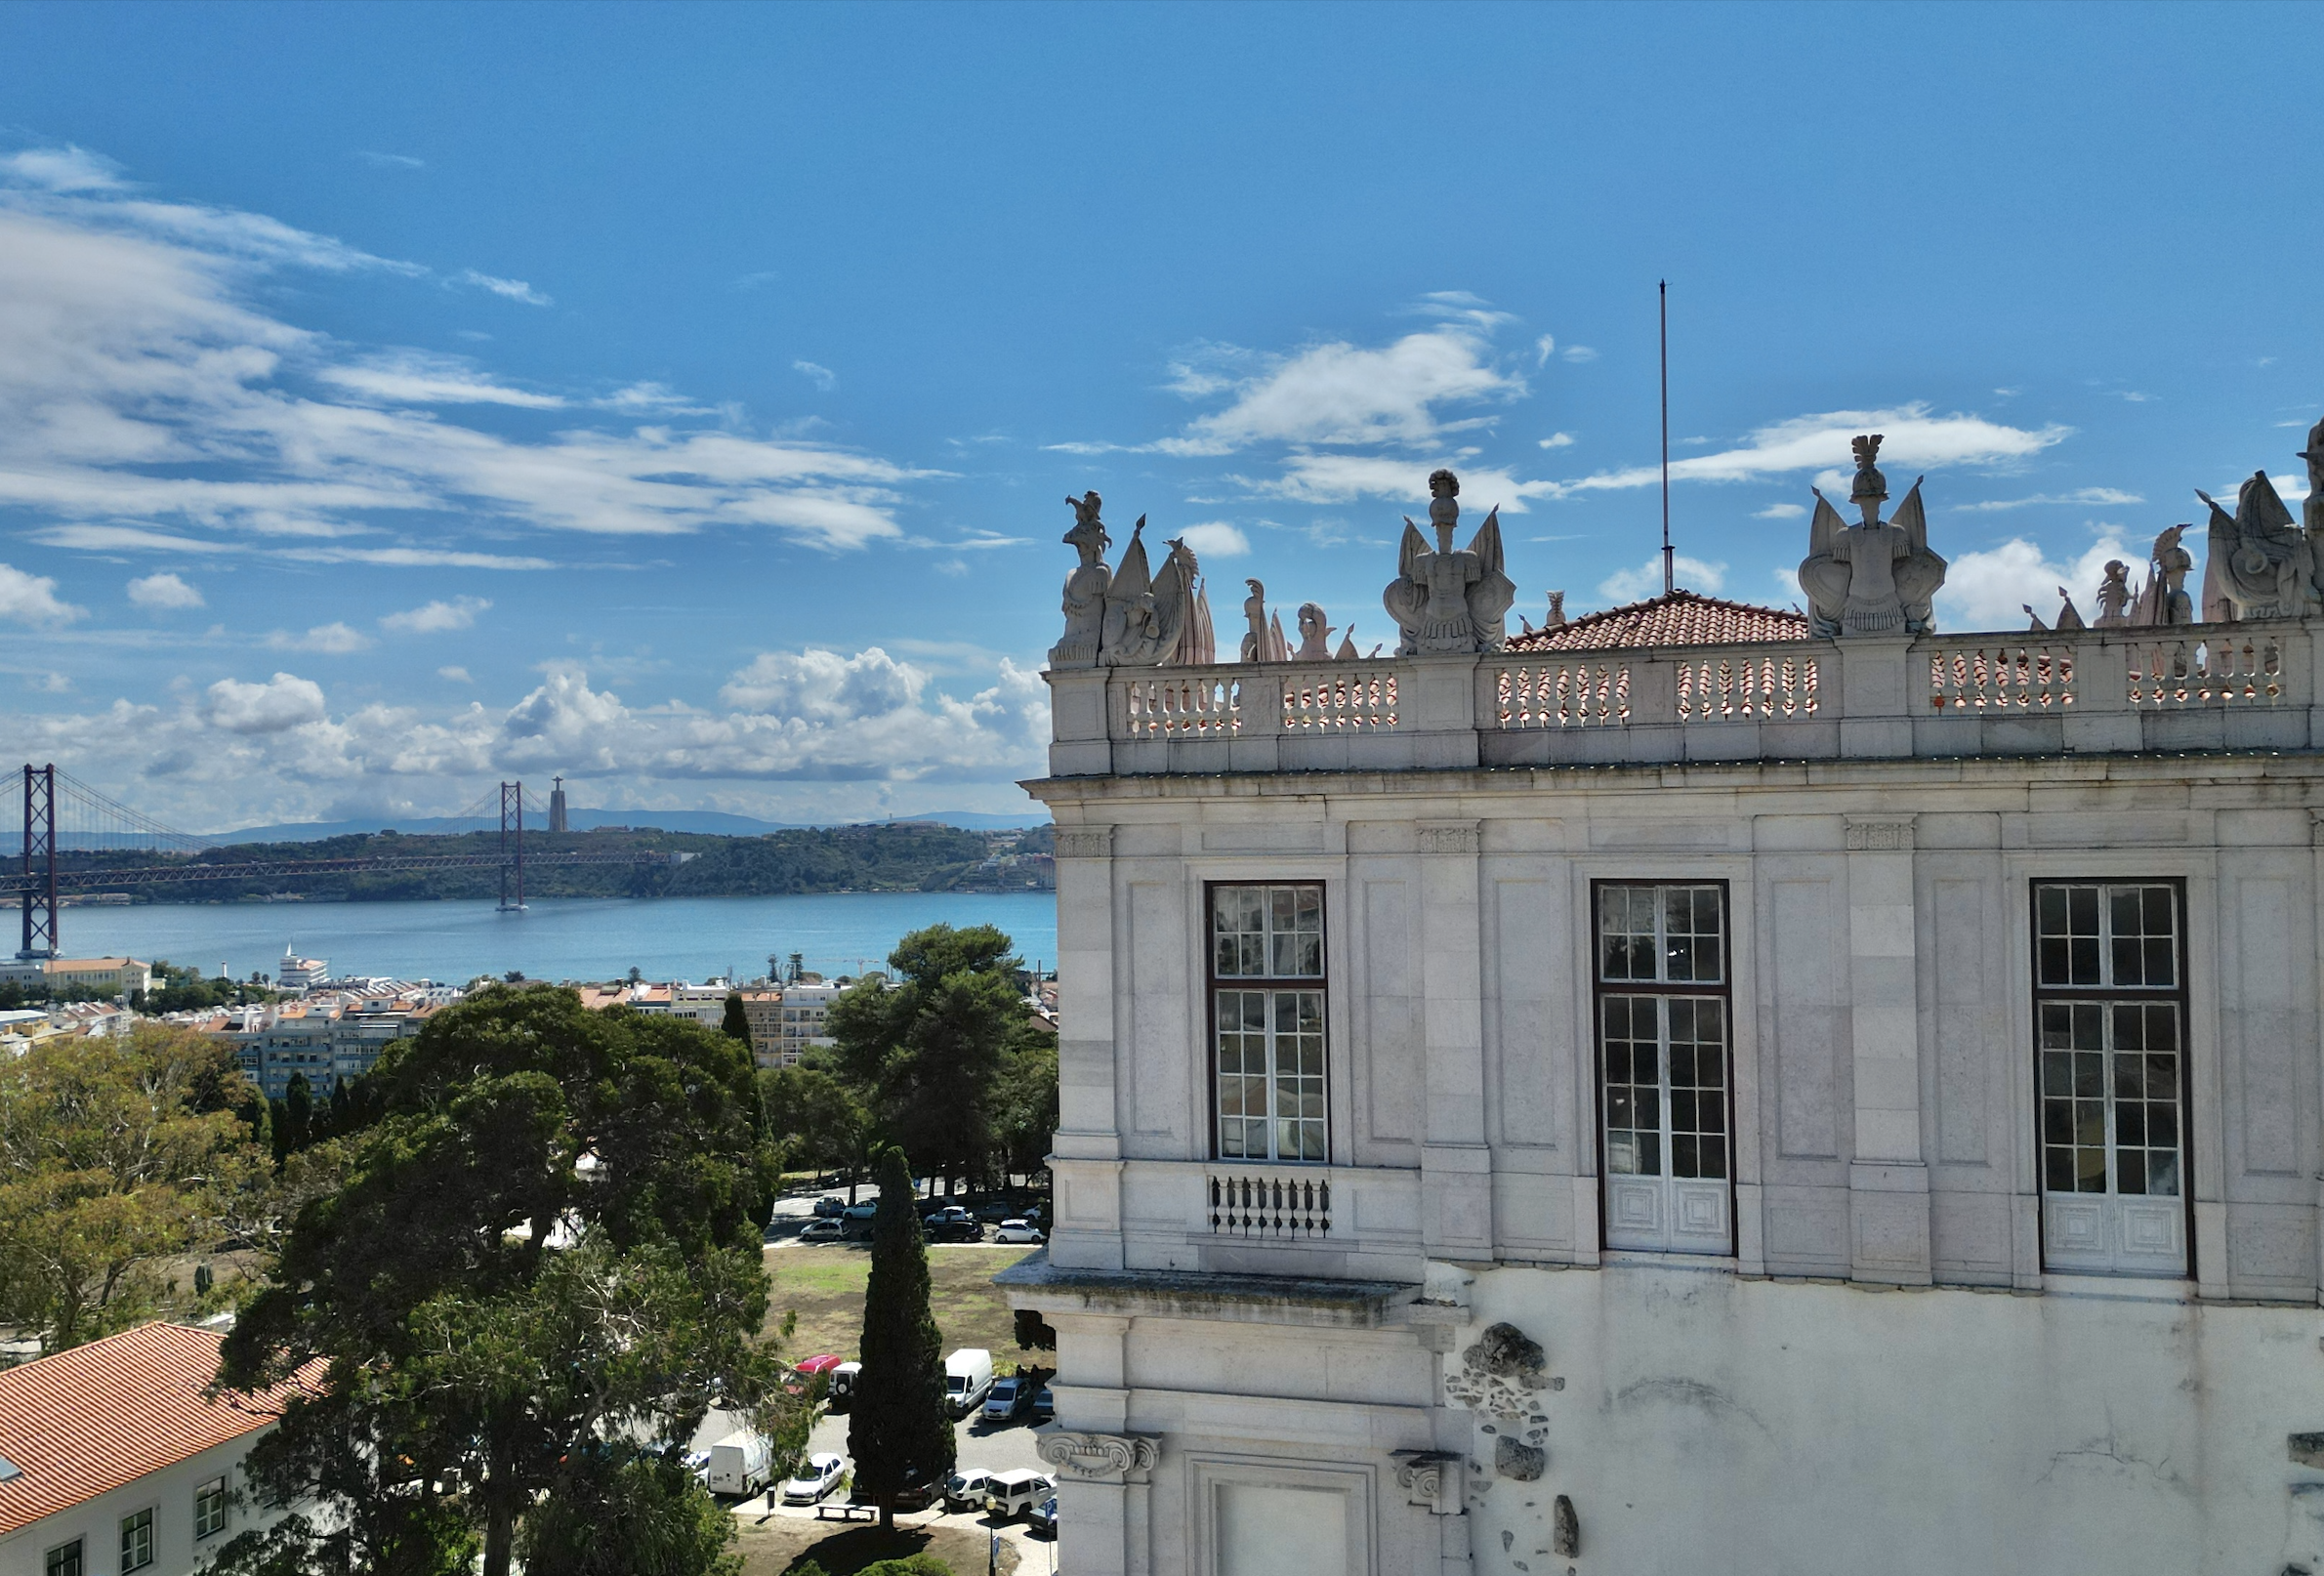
[1211,884,1332,1162]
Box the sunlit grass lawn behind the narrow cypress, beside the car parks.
[767,1241,1032,1366]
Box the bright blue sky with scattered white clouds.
[0,5,2324,830]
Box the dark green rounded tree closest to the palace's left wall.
[830,925,1029,1181]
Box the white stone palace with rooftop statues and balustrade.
[1002,426,2324,1576]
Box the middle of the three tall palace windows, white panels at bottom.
[1597,881,1733,1253]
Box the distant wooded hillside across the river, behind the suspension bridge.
[59,820,1056,902]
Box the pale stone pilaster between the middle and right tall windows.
[1847,816,1929,1285]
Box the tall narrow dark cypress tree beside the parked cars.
[849,1148,953,1527]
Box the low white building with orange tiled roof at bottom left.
[0,1325,309,1576]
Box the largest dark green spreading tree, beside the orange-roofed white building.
[219,985,778,1576]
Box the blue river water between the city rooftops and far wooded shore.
[59,892,1058,983]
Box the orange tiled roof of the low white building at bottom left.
[0,1325,307,1534]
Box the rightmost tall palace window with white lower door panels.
[2034,881,2187,1274]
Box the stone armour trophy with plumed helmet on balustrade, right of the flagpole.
[1799,433,1945,640]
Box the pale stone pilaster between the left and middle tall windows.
[1415,820,1492,1263]
